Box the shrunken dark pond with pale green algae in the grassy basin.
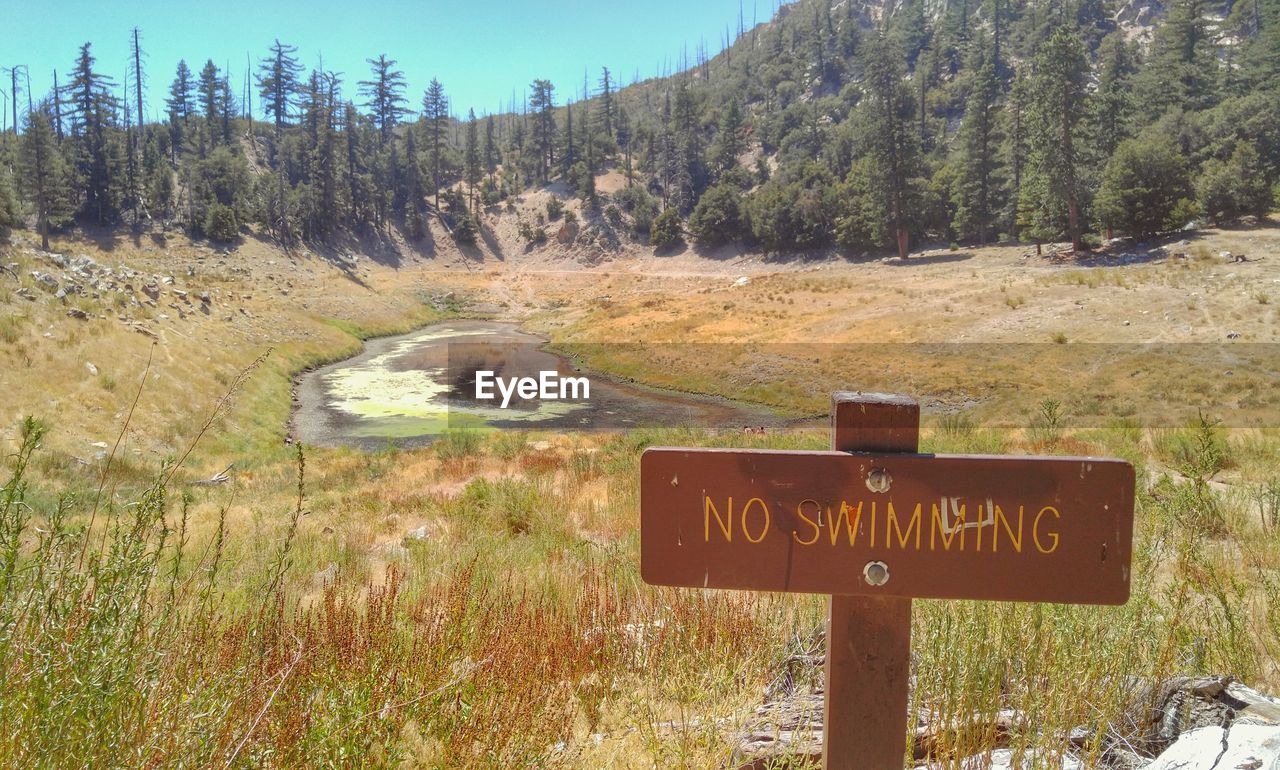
[291,321,786,449]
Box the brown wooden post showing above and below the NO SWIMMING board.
[822,393,920,770]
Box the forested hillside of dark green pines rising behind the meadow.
[0,0,1280,260]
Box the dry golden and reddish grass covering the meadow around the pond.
[0,223,1280,767]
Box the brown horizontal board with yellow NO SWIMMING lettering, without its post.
[640,448,1134,604]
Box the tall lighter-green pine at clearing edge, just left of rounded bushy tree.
[1019,27,1089,251]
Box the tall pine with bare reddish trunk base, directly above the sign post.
[859,32,919,260]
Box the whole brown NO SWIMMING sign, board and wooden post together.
[640,393,1134,770]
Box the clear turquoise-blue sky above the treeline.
[0,0,777,129]
